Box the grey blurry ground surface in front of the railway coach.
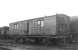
[0,39,78,50]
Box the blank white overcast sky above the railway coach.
[0,0,78,27]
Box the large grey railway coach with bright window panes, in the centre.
[9,14,70,44]
